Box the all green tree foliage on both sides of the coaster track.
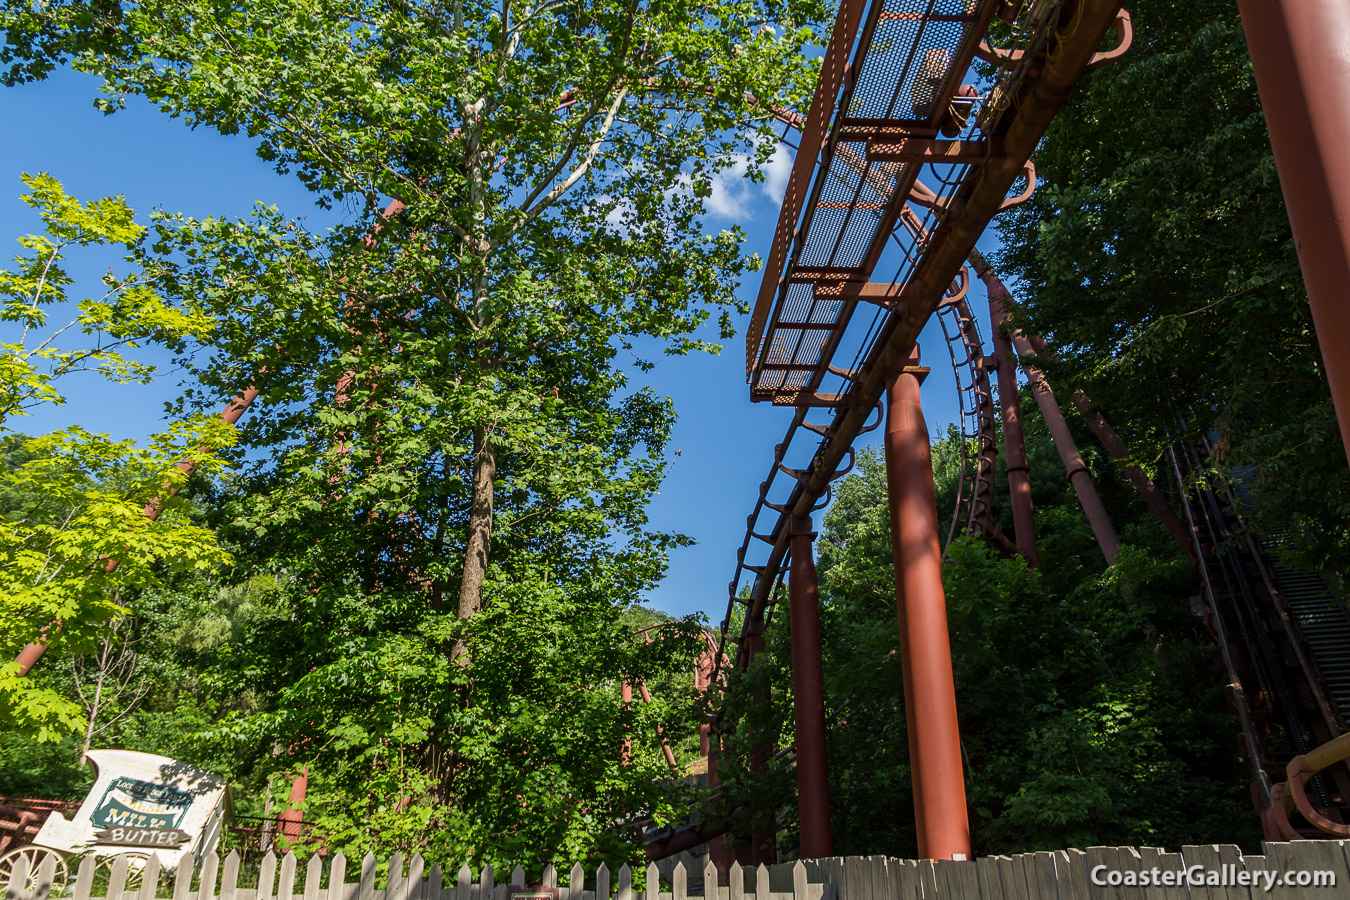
[0,0,1328,865]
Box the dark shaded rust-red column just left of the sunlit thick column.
[787,519,834,860]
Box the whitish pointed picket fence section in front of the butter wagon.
[5,851,836,900]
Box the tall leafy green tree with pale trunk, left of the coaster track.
[0,0,826,862]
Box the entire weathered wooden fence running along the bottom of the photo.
[10,841,1350,900]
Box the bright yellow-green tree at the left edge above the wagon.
[0,174,231,742]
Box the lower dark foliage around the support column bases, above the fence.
[724,397,1260,855]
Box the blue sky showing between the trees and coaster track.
[0,72,992,622]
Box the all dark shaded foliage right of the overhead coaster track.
[712,0,1312,853]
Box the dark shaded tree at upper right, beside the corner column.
[998,0,1350,580]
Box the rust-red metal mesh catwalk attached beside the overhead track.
[747,0,999,405]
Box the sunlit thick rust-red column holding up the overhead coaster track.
[886,351,971,860]
